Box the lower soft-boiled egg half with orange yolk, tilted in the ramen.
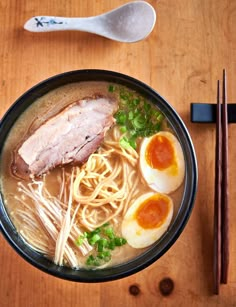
[121,192,174,248]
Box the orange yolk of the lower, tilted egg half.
[135,194,169,229]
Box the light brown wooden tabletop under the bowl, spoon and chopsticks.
[0,0,236,307]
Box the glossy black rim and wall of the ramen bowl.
[0,70,197,282]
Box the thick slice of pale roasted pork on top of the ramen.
[12,97,118,177]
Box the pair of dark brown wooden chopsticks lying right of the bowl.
[213,70,229,294]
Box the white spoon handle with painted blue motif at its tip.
[24,16,101,33]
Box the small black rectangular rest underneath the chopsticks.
[190,102,236,123]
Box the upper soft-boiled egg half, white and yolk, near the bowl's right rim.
[140,131,185,194]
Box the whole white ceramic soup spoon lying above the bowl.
[24,1,156,43]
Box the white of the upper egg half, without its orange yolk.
[139,131,185,194]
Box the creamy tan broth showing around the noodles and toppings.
[1,82,184,269]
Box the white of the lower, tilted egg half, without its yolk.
[121,192,174,248]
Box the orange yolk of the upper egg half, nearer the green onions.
[145,135,176,170]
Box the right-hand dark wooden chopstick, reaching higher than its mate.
[221,70,229,284]
